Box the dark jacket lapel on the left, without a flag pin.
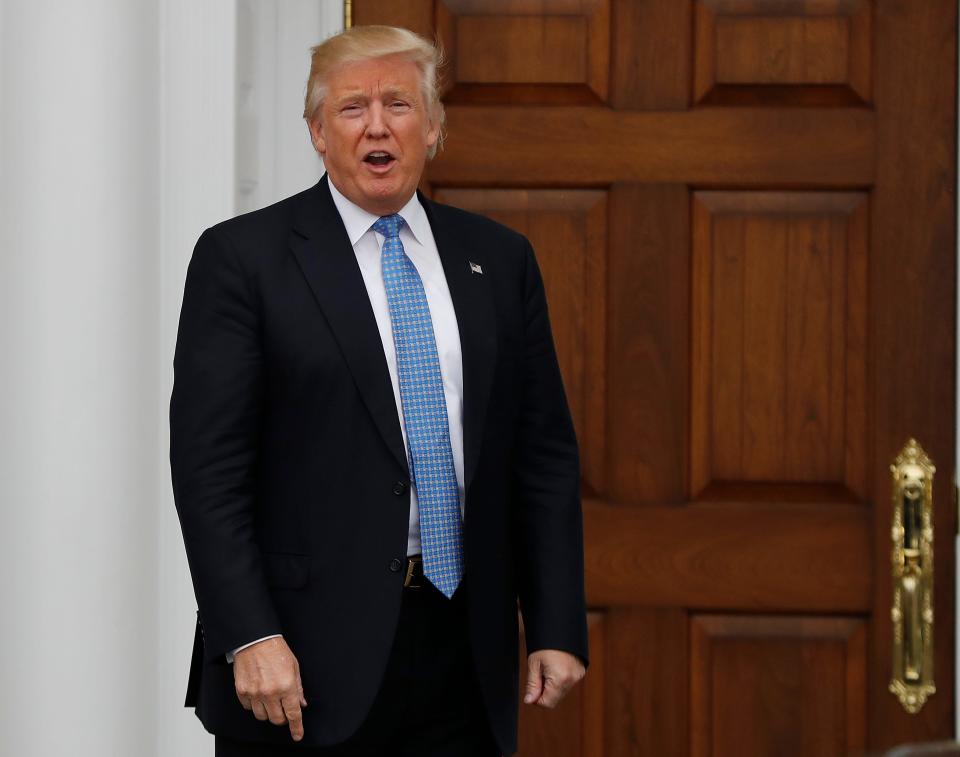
[290,176,407,470]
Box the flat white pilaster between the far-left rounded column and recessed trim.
[158,0,236,757]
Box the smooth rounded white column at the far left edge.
[0,0,160,757]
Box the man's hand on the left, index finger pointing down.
[233,636,307,741]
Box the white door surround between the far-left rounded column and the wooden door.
[156,0,343,757]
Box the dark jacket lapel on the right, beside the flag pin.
[419,193,497,499]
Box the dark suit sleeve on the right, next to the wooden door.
[514,242,588,665]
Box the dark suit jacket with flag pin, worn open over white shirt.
[170,178,587,754]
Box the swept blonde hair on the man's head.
[303,25,446,158]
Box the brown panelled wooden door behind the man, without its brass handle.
[353,0,957,757]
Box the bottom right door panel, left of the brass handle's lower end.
[690,614,867,757]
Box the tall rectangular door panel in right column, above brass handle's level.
[692,192,868,490]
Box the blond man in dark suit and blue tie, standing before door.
[170,26,587,757]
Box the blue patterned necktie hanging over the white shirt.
[373,214,463,597]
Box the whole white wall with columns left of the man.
[0,0,342,757]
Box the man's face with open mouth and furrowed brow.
[310,56,439,216]
